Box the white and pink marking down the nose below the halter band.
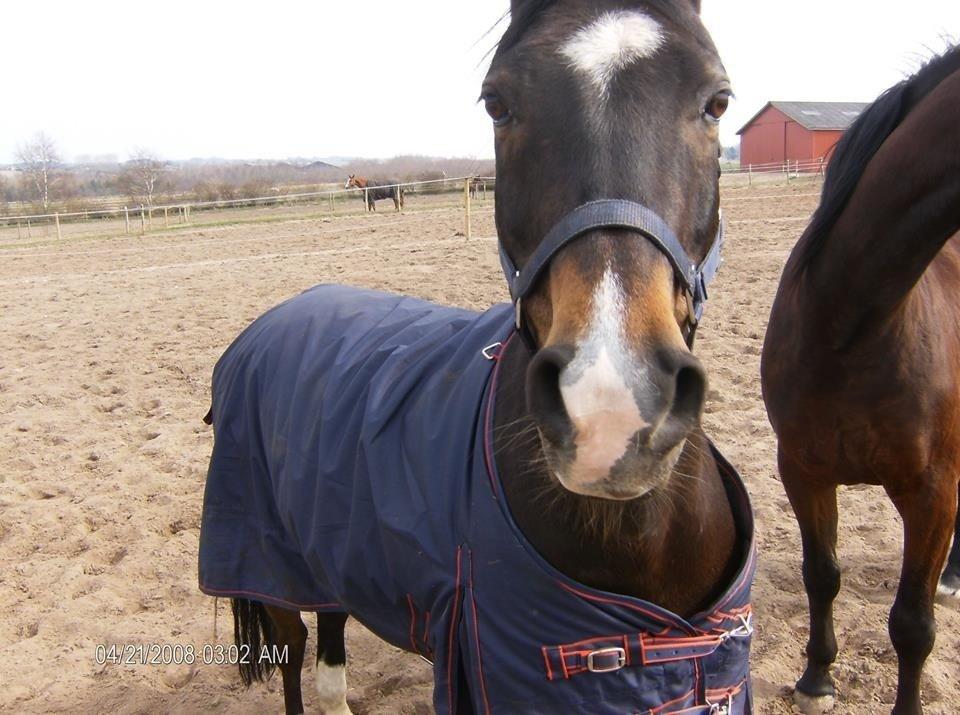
[560,267,649,481]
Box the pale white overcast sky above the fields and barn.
[0,0,960,162]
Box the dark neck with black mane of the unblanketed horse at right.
[781,47,960,348]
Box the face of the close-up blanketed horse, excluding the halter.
[482,0,730,499]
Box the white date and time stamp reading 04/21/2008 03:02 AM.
[94,643,290,666]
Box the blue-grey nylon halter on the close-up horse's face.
[499,199,723,350]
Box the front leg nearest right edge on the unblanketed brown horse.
[889,482,957,715]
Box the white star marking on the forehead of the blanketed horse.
[560,10,663,97]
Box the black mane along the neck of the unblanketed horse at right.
[794,46,960,271]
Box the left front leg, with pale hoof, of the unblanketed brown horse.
[780,453,840,710]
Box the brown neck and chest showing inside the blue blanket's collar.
[494,341,739,616]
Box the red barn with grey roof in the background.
[737,102,868,167]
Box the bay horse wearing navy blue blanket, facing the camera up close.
[200,0,755,715]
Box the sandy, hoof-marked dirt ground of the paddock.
[0,181,960,715]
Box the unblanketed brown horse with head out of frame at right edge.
[762,48,960,715]
